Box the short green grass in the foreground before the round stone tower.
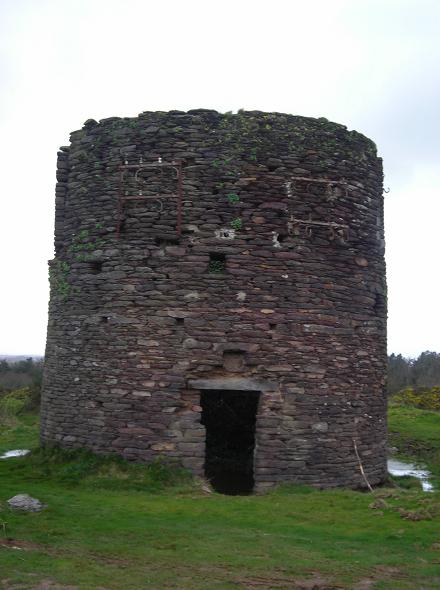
[0,410,440,590]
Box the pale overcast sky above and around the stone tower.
[0,0,440,356]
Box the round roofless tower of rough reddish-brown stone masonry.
[41,109,386,491]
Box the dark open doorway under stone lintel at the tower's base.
[200,390,260,495]
